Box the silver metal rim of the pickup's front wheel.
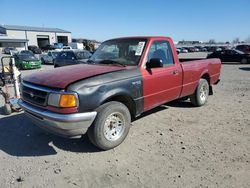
[103,112,125,141]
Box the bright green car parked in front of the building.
[14,50,41,69]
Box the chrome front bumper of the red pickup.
[18,99,97,138]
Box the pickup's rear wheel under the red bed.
[190,78,209,107]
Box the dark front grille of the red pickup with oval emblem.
[22,84,48,106]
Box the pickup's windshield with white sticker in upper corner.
[89,38,147,66]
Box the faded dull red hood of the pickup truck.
[23,64,126,89]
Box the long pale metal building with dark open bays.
[0,25,72,50]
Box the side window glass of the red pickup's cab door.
[147,41,174,66]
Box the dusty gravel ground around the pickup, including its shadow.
[0,63,250,188]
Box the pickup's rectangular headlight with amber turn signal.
[48,93,78,108]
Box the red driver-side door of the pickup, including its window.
[142,41,182,111]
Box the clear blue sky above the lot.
[0,0,250,42]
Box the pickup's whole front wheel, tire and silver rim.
[87,101,131,150]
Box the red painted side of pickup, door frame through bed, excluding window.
[139,37,221,111]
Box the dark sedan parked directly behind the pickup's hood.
[54,50,92,67]
